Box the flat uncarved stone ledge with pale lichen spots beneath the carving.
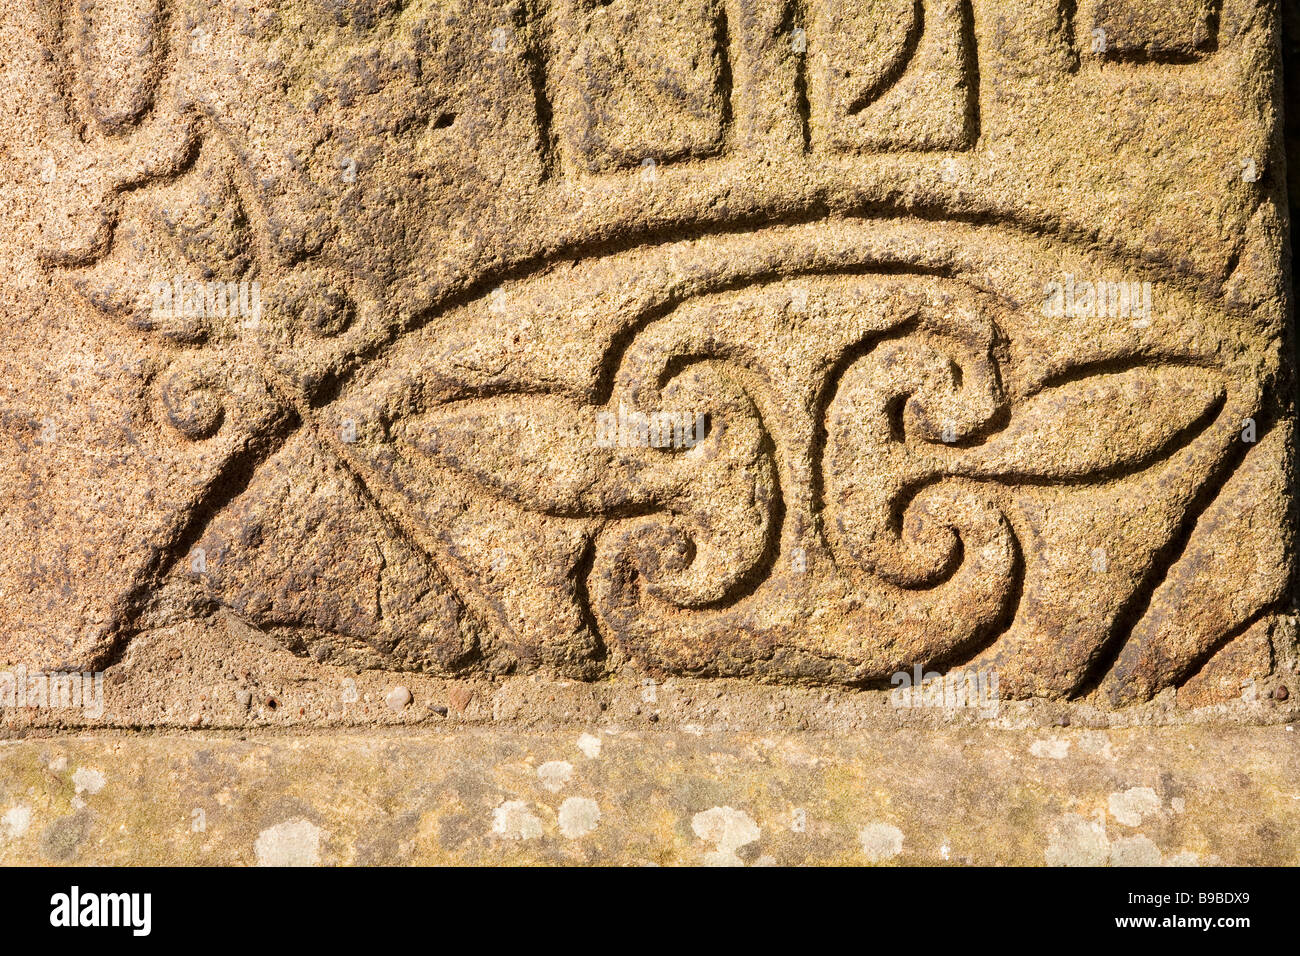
[0,724,1300,865]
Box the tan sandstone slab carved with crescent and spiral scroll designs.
[0,0,1296,722]
